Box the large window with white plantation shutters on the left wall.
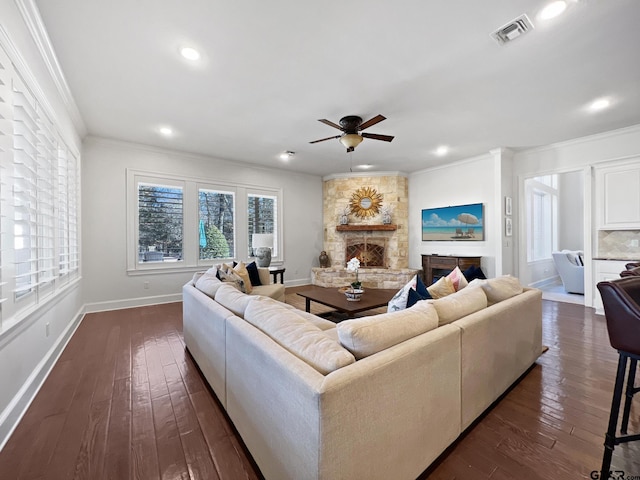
[0,45,80,331]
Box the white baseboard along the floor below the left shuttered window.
[0,309,84,450]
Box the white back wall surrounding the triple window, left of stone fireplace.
[82,138,323,310]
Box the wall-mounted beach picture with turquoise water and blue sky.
[422,203,484,242]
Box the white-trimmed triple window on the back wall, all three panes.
[127,170,283,275]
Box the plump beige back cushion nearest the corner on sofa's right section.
[337,302,438,359]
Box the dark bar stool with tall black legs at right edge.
[598,276,640,479]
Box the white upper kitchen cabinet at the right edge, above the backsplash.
[595,157,640,230]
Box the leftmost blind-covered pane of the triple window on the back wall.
[138,182,183,262]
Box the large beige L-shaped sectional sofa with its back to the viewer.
[183,277,542,480]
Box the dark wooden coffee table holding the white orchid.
[298,285,398,318]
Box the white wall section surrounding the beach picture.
[409,154,503,277]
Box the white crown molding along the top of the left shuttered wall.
[15,0,87,137]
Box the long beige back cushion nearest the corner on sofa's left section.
[244,297,355,375]
